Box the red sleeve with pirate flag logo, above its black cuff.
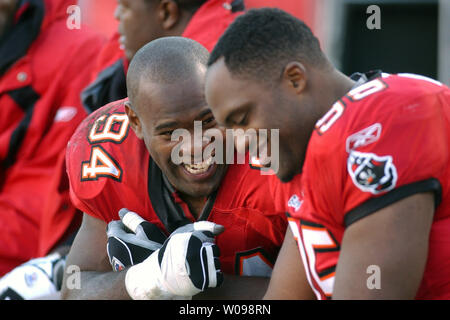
[311,75,450,227]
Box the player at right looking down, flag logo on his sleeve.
[206,9,450,299]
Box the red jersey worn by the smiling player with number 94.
[66,100,287,276]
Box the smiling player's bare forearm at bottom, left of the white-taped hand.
[61,270,130,300]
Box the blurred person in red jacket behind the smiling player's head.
[82,0,244,111]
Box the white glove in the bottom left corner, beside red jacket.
[0,253,66,300]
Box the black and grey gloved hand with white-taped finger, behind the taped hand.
[106,208,167,271]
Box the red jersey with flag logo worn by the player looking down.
[288,74,450,299]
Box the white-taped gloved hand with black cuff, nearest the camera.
[125,221,224,300]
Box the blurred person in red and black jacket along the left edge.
[0,0,103,298]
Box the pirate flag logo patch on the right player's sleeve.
[347,151,397,194]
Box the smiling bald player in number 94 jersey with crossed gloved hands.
[63,37,287,299]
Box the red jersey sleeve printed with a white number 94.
[66,100,129,222]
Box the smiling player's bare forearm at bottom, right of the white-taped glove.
[193,274,270,300]
